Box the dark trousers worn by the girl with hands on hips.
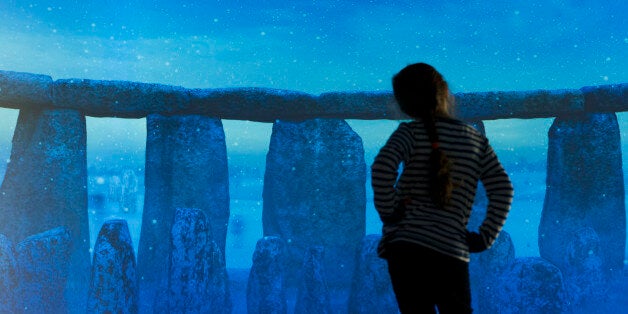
[386,242,472,314]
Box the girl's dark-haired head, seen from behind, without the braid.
[393,63,451,119]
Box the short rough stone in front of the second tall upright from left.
[168,208,231,313]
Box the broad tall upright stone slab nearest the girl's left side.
[262,119,366,288]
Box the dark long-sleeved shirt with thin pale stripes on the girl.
[371,118,513,262]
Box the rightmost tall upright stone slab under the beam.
[539,113,626,276]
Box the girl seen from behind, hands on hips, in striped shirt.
[371,63,513,314]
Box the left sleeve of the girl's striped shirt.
[371,123,412,223]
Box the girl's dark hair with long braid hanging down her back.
[393,63,454,208]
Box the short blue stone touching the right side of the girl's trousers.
[469,230,515,313]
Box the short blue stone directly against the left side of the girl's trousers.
[349,234,399,314]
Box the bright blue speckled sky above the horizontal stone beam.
[0,0,628,94]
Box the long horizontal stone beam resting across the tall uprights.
[0,71,628,122]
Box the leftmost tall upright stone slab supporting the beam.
[0,109,90,312]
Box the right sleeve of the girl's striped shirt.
[478,140,514,250]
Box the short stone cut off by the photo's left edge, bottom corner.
[0,234,21,313]
